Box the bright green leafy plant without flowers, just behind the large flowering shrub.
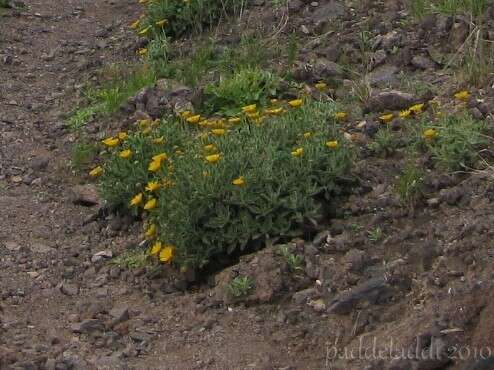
[205,68,280,115]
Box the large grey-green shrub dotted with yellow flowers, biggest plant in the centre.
[100,102,352,268]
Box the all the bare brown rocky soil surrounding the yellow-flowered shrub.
[0,0,494,370]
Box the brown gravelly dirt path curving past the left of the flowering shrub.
[0,0,302,369]
